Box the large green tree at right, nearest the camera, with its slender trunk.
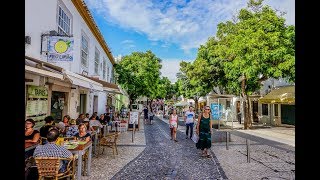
[217,0,295,129]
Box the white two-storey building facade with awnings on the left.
[25,0,117,125]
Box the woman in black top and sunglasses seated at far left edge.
[24,119,40,143]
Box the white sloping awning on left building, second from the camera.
[65,70,103,91]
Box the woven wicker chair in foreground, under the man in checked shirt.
[34,156,76,180]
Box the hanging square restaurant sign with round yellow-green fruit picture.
[47,36,74,61]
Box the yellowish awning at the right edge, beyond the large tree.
[259,86,295,104]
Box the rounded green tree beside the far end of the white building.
[115,51,162,109]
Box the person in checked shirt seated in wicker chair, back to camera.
[33,127,73,172]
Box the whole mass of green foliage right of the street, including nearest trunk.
[178,0,295,129]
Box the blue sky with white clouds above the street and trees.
[85,0,295,83]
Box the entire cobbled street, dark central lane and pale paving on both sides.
[82,117,295,180]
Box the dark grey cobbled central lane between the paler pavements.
[112,118,227,180]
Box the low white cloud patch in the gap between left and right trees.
[160,59,192,83]
